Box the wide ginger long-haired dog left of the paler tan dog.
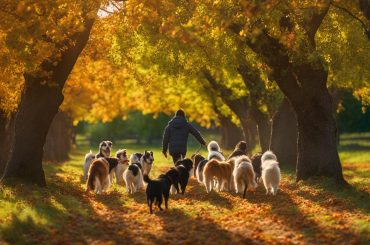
[203,158,235,193]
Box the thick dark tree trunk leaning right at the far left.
[2,19,94,186]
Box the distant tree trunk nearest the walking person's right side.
[219,115,243,149]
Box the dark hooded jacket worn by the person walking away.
[162,116,206,155]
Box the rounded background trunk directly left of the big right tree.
[270,98,298,167]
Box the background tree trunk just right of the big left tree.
[43,111,72,162]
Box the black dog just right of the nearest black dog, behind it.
[171,158,193,195]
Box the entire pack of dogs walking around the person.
[83,141,281,213]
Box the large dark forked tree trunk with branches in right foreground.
[241,5,346,184]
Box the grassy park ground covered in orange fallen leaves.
[0,134,370,244]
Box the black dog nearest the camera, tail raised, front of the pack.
[144,174,172,214]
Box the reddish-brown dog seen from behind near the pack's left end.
[86,153,121,194]
